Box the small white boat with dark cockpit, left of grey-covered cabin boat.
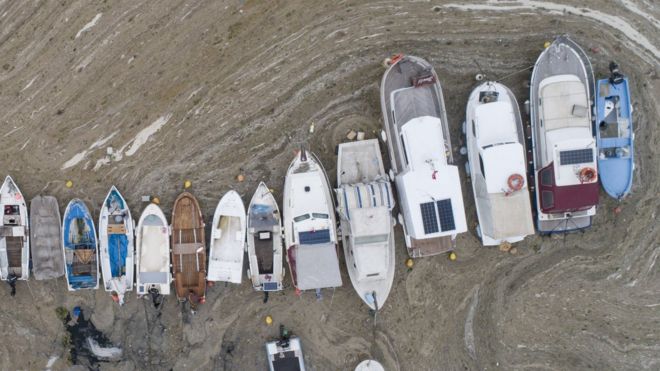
[247,182,285,292]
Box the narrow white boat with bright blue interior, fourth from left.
[99,186,135,305]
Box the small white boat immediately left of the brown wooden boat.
[135,203,172,296]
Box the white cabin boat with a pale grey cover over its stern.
[283,149,342,291]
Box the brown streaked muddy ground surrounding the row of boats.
[0,0,660,370]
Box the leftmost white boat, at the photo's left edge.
[0,176,30,281]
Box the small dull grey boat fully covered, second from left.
[30,196,64,280]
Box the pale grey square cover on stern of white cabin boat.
[296,243,341,290]
